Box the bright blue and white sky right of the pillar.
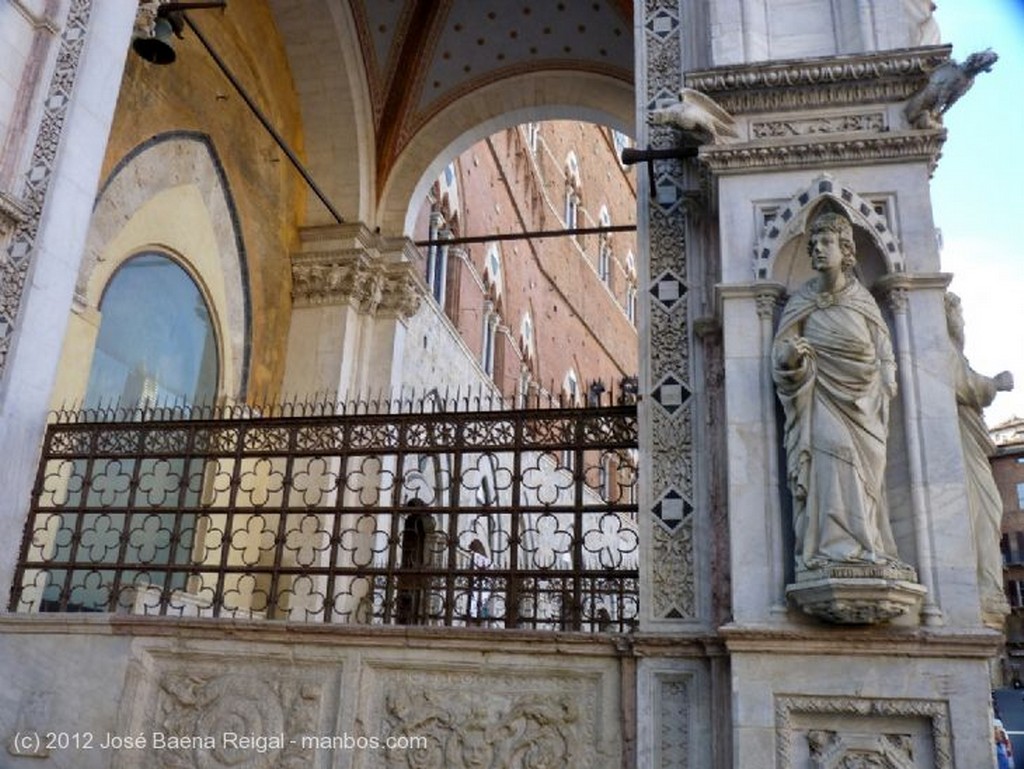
[932,0,1024,426]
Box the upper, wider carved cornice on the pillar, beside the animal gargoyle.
[685,45,952,115]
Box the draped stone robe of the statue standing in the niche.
[772,279,897,570]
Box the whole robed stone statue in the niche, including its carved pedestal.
[772,210,921,623]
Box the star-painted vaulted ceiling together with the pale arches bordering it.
[268,0,634,233]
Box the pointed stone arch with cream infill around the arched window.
[73,131,251,400]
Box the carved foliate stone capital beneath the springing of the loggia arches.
[292,224,426,319]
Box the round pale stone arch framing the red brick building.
[379,71,634,234]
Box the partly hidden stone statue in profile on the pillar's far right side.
[945,293,1014,628]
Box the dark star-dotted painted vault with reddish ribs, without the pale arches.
[350,0,634,183]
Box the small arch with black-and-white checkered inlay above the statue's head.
[754,174,905,283]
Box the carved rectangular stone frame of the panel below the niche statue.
[775,694,953,769]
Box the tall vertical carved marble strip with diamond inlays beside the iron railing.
[638,0,699,620]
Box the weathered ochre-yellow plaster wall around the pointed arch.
[97,2,304,403]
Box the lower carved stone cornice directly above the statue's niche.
[698,129,946,174]
